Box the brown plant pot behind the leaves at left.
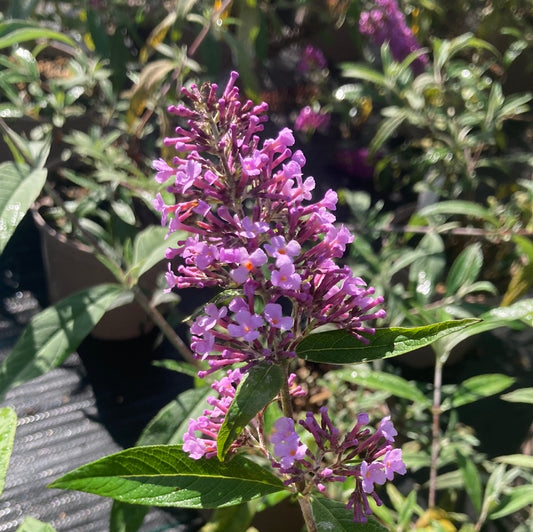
[32,207,163,340]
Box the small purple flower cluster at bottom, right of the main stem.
[270,407,406,522]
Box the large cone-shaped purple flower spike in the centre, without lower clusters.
[154,73,385,374]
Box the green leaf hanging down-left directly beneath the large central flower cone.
[217,364,283,460]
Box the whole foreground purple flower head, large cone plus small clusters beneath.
[154,72,403,521]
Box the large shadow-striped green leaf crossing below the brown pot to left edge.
[0,284,122,396]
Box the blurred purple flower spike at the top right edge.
[359,0,429,74]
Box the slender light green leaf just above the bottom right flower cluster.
[335,366,431,406]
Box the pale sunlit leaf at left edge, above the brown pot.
[0,162,47,254]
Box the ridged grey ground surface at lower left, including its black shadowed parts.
[0,214,200,532]
